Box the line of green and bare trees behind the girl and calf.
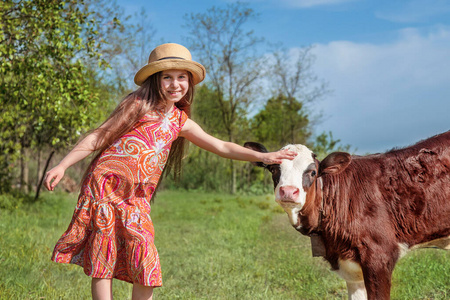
[0,0,348,198]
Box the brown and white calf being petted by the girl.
[245,131,450,299]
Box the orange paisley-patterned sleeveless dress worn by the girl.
[52,108,187,287]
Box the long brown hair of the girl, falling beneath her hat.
[83,72,195,186]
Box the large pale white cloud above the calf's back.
[313,27,450,153]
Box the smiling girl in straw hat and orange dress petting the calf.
[45,44,295,299]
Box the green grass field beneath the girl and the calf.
[0,191,450,300]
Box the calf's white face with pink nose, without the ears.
[274,145,317,227]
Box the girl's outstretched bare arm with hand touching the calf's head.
[180,119,296,164]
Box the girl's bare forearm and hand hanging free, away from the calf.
[44,131,98,191]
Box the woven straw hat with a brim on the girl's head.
[134,43,206,85]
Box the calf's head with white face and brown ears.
[244,142,351,230]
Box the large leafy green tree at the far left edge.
[0,0,109,192]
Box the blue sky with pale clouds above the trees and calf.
[117,0,450,155]
